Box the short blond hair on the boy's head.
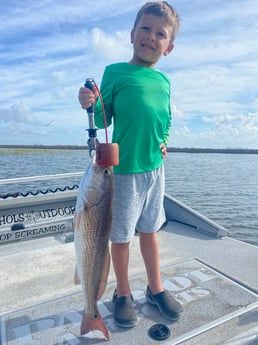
[134,1,180,43]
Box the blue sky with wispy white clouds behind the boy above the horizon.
[0,0,258,149]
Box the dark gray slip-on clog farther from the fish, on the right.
[146,287,183,321]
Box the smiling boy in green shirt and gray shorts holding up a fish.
[79,1,183,327]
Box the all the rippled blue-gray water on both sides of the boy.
[0,149,258,245]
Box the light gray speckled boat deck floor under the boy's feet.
[0,221,258,345]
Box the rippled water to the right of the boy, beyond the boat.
[165,153,258,244]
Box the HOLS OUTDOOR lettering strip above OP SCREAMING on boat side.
[0,206,75,227]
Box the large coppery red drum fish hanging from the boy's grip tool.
[74,162,113,340]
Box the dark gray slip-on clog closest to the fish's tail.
[112,290,137,328]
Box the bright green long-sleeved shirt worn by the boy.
[95,63,171,174]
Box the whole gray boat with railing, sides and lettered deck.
[0,172,258,345]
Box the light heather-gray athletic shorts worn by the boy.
[110,165,165,243]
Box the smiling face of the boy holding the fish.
[131,14,174,67]
